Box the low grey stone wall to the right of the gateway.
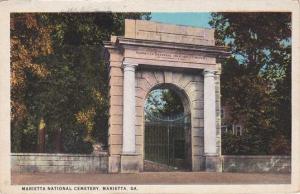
[222,155,291,173]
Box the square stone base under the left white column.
[121,153,140,173]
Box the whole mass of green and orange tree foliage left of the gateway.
[11,12,149,153]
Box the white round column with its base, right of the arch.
[204,70,220,171]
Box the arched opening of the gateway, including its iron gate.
[144,84,191,171]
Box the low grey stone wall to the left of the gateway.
[11,153,108,173]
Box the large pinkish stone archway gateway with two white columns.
[105,20,229,173]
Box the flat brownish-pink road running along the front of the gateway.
[12,172,291,185]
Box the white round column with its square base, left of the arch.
[121,62,139,173]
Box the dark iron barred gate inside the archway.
[145,113,190,169]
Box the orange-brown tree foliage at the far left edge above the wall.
[10,13,52,152]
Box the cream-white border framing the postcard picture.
[0,0,300,194]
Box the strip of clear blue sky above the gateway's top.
[151,12,211,28]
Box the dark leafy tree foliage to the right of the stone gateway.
[210,13,291,154]
